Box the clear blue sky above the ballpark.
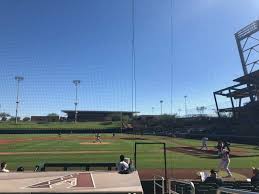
[0,0,259,116]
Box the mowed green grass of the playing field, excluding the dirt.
[0,134,259,170]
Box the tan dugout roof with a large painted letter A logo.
[0,171,143,194]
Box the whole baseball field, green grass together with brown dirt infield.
[0,134,259,178]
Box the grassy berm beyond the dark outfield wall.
[0,121,121,129]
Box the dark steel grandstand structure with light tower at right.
[214,20,259,119]
